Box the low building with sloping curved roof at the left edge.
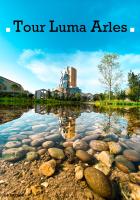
[0,76,24,93]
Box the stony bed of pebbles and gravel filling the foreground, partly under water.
[0,107,140,200]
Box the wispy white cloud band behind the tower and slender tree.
[18,49,140,93]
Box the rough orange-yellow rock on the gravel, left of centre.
[39,159,56,177]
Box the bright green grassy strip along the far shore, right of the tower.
[86,100,140,107]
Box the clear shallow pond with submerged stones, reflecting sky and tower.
[0,105,140,199]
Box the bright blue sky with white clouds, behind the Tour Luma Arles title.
[0,0,140,93]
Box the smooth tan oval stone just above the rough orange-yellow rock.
[48,148,65,160]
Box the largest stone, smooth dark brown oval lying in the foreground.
[84,167,112,198]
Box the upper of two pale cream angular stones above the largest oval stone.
[96,151,114,168]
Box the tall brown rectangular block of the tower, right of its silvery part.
[67,67,77,87]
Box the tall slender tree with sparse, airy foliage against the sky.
[98,54,122,100]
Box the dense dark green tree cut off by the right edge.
[128,71,140,101]
